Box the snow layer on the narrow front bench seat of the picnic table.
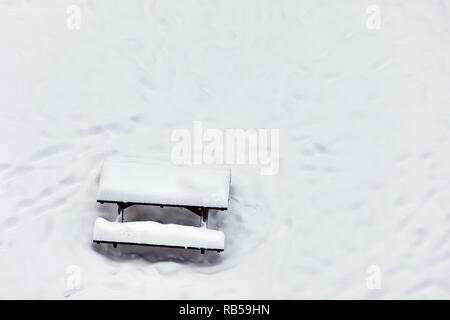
[93,218,225,249]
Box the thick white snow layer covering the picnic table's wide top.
[97,160,231,208]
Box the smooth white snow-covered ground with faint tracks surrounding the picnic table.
[0,0,450,299]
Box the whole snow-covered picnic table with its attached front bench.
[93,161,231,253]
